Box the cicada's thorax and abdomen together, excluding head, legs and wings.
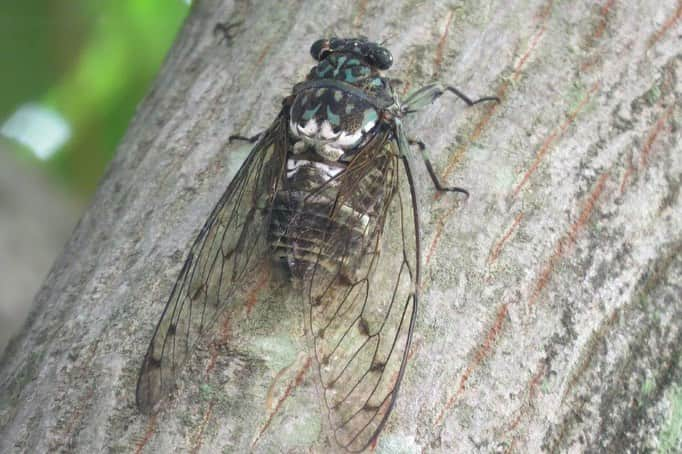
[270,53,393,281]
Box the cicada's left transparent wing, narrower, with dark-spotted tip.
[136,115,288,413]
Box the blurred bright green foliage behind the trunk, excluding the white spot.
[0,0,189,196]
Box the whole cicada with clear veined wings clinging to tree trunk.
[136,38,496,451]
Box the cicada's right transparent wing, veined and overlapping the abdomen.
[306,131,420,451]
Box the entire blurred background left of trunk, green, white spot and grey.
[0,0,190,352]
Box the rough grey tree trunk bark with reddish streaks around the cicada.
[0,0,682,452]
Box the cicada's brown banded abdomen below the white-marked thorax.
[269,154,384,281]
